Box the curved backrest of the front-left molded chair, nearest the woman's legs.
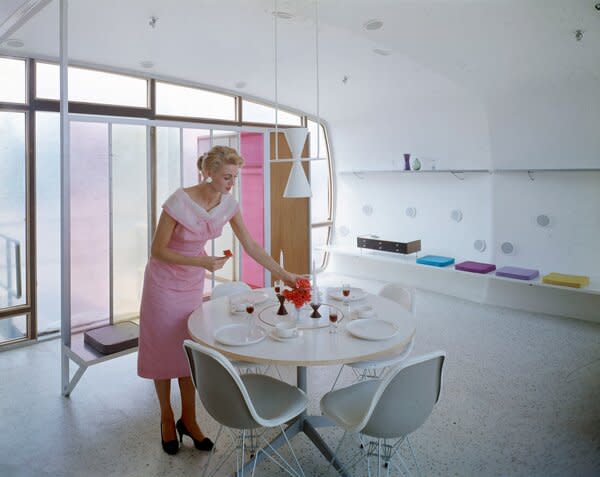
[183,340,262,429]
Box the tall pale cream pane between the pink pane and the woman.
[111,124,148,322]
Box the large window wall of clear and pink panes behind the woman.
[0,54,332,344]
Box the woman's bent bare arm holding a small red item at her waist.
[150,212,228,272]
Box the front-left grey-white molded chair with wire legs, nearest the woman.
[183,340,308,477]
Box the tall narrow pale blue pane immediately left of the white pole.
[35,112,61,333]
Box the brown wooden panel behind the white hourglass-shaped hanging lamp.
[270,132,310,280]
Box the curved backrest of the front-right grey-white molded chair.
[360,351,446,438]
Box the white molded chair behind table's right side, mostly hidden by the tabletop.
[331,283,416,391]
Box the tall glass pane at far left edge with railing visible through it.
[0,112,27,308]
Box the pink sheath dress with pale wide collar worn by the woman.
[138,189,239,379]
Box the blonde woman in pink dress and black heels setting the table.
[138,146,298,454]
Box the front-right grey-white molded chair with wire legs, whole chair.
[321,351,446,476]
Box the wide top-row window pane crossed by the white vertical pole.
[36,63,148,108]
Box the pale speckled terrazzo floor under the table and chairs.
[0,292,600,477]
